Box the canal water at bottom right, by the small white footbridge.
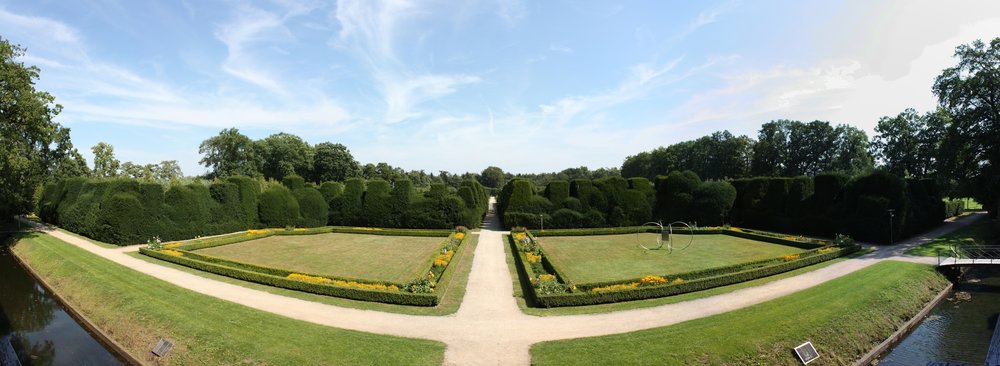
[878,267,1000,366]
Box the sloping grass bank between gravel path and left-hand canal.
[13,234,445,365]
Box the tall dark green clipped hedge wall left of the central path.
[38,176,488,244]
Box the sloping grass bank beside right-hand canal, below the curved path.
[531,261,948,365]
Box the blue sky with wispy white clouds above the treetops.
[0,0,1000,175]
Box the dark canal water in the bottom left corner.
[0,234,122,366]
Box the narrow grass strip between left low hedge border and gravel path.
[128,235,479,316]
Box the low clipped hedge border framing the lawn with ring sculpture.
[507,227,861,308]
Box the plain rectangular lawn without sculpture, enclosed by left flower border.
[197,233,445,283]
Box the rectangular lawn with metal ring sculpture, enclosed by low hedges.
[538,233,804,284]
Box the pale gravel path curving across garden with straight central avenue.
[15,209,983,365]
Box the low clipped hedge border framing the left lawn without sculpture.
[139,228,471,307]
